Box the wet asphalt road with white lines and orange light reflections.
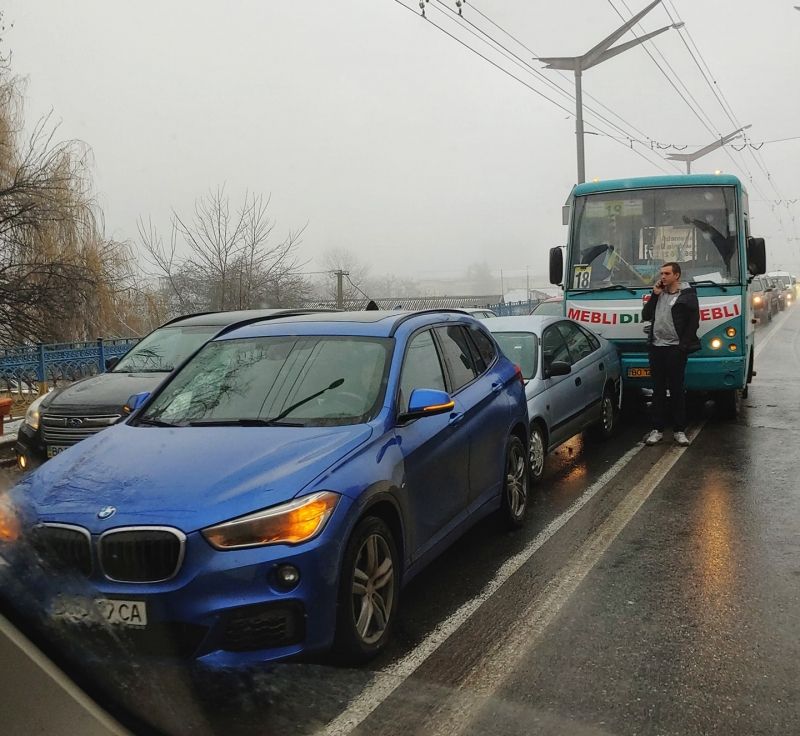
[1,308,800,735]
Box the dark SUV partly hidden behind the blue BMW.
[15,309,319,469]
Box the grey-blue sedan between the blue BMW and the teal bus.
[487,315,622,482]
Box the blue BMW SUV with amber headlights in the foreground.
[6,311,528,666]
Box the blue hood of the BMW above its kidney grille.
[17,424,372,533]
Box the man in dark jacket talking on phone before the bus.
[642,262,700,446]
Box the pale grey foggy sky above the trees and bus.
[3,0,800,285]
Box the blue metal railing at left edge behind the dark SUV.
[0,338,139,393]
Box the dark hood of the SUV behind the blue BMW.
[44,372,169,413]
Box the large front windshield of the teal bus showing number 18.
[567,186,740,291]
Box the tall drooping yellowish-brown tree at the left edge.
[0,64,153,345]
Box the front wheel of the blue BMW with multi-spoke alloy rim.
[334,516,399,662]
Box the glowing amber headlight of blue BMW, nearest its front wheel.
[202,491,339,550]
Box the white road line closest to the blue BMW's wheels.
[320,442,644,736]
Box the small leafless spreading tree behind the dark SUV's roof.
[139,188,308,314]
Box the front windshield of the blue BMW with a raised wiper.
[141,336,393,426]
